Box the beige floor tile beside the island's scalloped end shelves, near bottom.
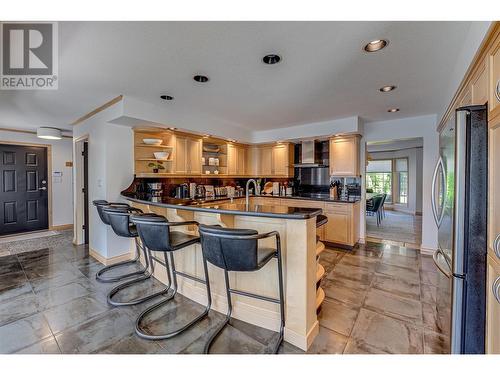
[318,300,359,336]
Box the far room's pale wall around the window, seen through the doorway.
[369,148,422,214]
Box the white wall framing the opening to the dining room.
[361,115,439,251]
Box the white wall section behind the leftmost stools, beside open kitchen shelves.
[73,104,134,258]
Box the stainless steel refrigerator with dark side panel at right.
[432,106,488,354]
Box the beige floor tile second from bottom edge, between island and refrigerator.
[363,289,422,325]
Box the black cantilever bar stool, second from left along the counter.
[103,206,169,306]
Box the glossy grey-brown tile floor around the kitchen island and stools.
[0,238,447,353]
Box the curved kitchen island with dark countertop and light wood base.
[122,192,322,350]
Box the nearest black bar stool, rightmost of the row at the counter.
[199,225,285,353]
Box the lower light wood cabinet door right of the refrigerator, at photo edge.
[486,256,500,354]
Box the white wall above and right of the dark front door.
[0,130,73,226]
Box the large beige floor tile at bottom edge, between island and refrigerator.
[351,309,423,354]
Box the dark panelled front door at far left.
[0,144,49,236]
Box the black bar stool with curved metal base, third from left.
[130,214,212,340]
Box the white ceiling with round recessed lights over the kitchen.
[0,22,492,135]
